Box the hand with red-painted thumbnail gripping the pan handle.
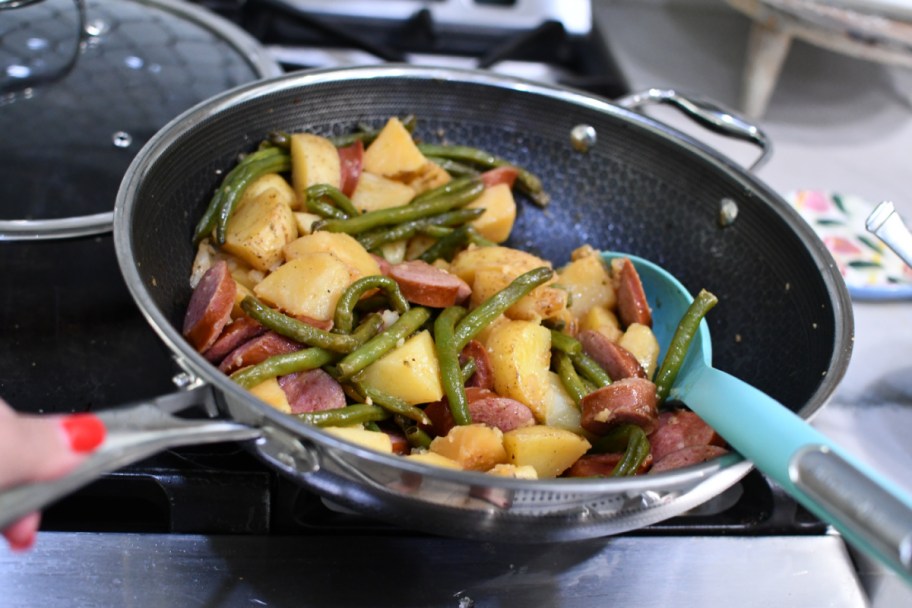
[0,399,105,551]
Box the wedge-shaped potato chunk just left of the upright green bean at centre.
[358,330,443,405]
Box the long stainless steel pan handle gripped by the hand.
[0,386,261,530]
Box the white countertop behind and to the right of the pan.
[594,0,912,606]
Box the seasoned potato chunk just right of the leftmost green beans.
[222,188,298,272]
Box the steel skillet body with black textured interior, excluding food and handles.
[0,65,852,542]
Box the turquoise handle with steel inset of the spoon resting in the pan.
[671,366,912,584]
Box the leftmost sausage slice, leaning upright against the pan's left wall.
[183,260,237,352]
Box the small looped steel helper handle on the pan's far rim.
[615,89,772,171]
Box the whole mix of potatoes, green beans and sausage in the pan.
[184,117,719,480]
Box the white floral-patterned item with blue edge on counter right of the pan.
[785,190,912,299]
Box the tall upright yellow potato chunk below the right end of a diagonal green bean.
[485,321,551,422]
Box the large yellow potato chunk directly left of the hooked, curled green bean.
[253,253,351,321]
